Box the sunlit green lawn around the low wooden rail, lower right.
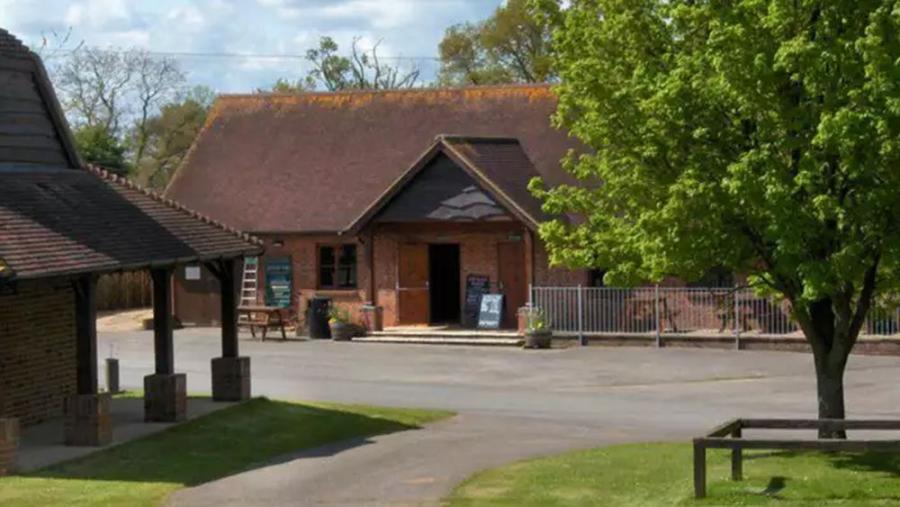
[448,444,900,507]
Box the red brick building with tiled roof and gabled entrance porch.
[166,85,589,327]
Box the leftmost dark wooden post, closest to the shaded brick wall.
[74,276,98,394]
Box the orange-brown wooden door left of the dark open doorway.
[397,243,431,325]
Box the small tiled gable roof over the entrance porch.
[344,135,548,232]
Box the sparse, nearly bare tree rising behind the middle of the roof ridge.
[302,37,420,91]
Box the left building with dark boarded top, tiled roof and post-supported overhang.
[0,29,262,468]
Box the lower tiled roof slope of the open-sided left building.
[0,168,261,279]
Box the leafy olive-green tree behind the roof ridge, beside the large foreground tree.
[438,0,561,86]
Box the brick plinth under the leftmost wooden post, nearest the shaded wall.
[63,393,112,447]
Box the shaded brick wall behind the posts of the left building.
[0,282,76,425]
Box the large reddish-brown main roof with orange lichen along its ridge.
[166,85,579,232]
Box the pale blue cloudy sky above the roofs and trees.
[0,0,502,93]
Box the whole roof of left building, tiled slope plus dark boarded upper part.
[0,29,262,280]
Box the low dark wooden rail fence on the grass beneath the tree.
[694,419,900,498]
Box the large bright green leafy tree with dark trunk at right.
[532,0,900,436]
